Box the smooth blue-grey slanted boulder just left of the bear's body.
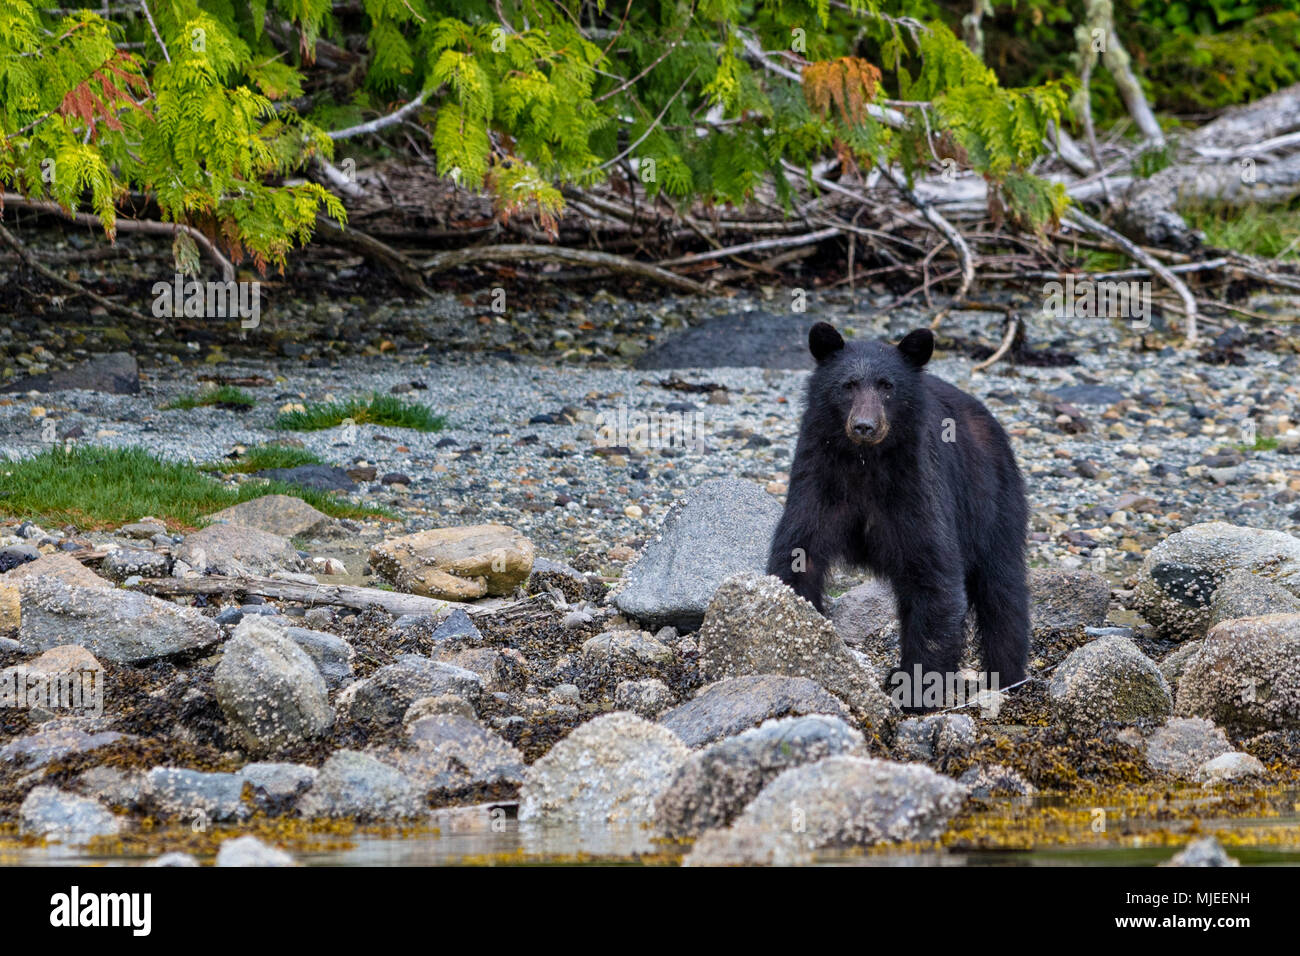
[614,479,781,631]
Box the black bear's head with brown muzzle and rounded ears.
[809,323,935,446]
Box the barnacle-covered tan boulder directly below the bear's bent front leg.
[697,575,897,732]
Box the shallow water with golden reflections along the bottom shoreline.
[0,788,1300,866]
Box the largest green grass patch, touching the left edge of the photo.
[0,446,390,529]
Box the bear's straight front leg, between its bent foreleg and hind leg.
[891,568,966,710]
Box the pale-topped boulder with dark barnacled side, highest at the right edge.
[1134,522,1300,641]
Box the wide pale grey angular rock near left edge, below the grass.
[9,574,221,663]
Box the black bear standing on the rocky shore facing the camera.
[767,323,1030,709]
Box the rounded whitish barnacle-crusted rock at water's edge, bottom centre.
[519,711,689,826]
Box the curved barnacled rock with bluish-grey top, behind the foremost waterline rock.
[657,715,866,838]
